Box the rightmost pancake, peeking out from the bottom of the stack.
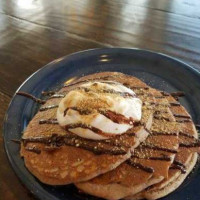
[127,96,199,199]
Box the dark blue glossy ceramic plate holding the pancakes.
[4,48,200,200]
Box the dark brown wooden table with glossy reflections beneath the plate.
[0,0,200,200]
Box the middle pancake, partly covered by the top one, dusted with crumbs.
[76,85,179,199]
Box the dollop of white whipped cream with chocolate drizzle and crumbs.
[57,81,142,140]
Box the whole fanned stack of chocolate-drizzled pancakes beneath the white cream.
[18,72,200,200]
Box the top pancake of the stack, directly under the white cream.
[18,72,154,185]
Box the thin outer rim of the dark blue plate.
[2,47,200,199]
